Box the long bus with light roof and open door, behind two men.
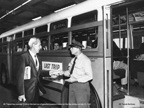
[0,0,144,108]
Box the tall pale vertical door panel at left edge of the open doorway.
[103,6,112,108]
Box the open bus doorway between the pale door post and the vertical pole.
[111,1,132,108]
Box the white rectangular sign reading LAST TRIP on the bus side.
[42,61,62,71]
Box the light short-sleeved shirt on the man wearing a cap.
[69,53,93,83]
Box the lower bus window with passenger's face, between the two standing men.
[50,33,68,50]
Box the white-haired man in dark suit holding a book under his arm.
[17,37,44,107]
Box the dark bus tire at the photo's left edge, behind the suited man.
[1,64,8,86]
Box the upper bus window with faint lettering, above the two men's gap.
[50,19,68,31]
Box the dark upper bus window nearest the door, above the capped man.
[72,10,97,26]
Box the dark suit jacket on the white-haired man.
[17,51,44,102]
